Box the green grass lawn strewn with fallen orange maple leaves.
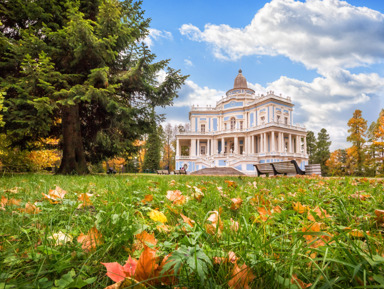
[0,174,384,288]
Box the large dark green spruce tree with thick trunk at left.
[0,0,186,174]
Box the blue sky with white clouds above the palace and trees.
[142,0,384,149]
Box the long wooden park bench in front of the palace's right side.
[254,160,305,176]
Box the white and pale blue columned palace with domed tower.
[176,70,308,175]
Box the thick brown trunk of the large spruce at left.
[57,104,89,175]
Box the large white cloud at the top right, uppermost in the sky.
[180,0,384,71]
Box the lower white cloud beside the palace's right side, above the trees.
[267,69,384,149]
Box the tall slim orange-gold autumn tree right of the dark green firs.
[347,109,367,175]
